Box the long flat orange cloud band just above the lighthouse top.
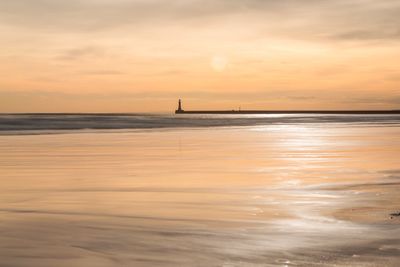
[1,88,400,104]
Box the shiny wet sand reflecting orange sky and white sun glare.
[0,124,400,267]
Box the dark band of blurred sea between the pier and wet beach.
[0,113,400,134]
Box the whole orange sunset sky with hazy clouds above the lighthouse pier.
[0,0,400,112]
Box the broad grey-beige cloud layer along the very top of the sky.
[0,0,400,41]
